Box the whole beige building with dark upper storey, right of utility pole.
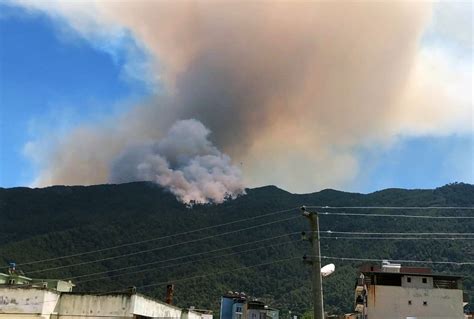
[355,261,464,319]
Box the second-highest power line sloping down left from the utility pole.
[29,216,299,274]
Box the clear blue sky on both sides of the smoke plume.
[0,1,474,192]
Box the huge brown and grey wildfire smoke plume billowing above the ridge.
[16,1,473,195]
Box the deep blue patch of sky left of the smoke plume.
[0,5,148,187]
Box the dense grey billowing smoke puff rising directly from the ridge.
[110,119,245,204]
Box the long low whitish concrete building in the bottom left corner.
[0,265,212,319]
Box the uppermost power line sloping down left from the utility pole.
[12,207,298,268]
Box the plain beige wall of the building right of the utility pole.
[367,286,464,319]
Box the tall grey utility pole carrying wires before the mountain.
[301,206,324,319]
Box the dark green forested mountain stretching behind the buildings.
[0,182,474,317]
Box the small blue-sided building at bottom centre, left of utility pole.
[220,291,279,319]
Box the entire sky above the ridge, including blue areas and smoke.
[0,1,474,201]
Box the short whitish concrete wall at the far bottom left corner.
[0,286,60,319]
